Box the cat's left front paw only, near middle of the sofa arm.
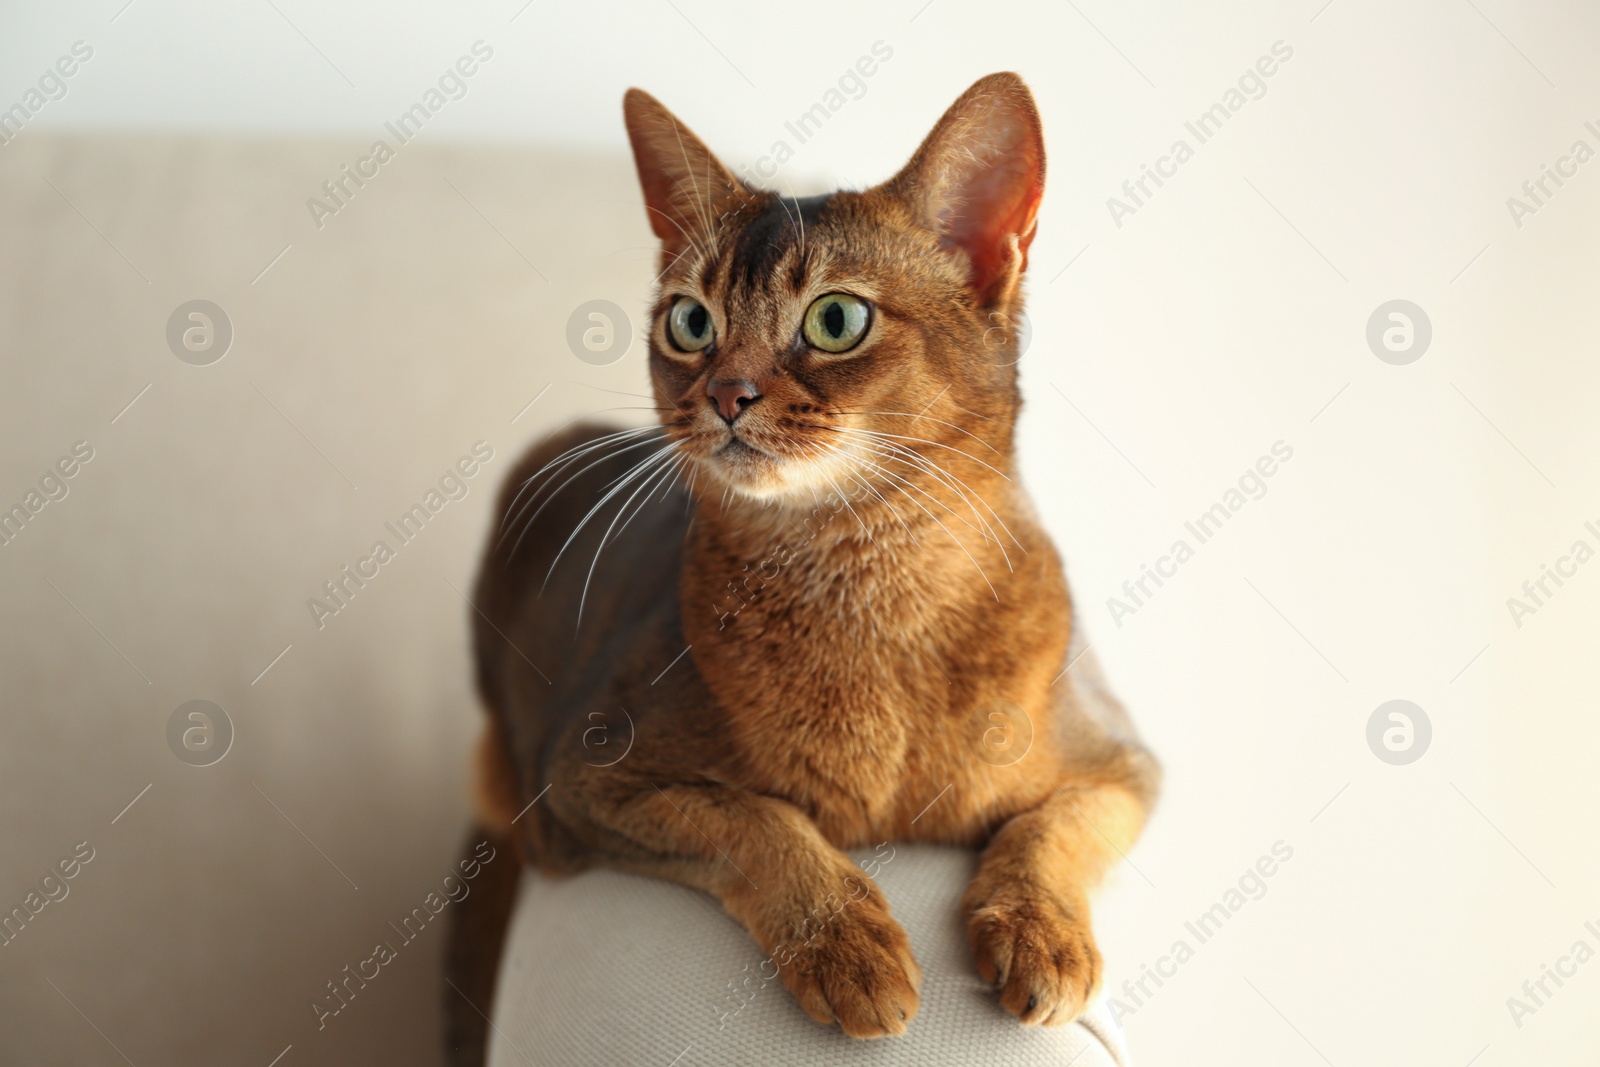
[774,891,922,1038]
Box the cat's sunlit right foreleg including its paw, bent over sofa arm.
[962,782,1146,1025]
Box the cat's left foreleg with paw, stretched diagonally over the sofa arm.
[576,784,922,1038]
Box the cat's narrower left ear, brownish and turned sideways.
[622,90,742,256]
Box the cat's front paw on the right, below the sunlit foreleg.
[966,891,1101,1025]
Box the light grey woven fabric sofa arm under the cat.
[490,845,1128,1067]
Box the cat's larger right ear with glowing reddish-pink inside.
[885,74,1045,307]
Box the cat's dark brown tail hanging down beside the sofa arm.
[443,819,522,1067]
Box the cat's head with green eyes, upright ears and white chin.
[624,74,1045,504]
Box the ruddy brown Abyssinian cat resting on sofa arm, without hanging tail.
[458,74,1158,1038]
